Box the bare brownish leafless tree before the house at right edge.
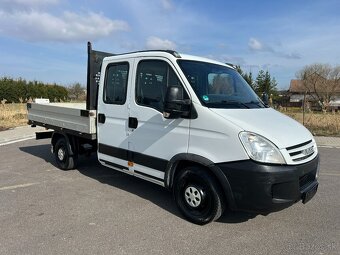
[296,64,340,110]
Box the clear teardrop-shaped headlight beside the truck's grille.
[239,132,286,164]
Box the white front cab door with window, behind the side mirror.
[129,58,189,184]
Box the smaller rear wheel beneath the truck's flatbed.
[54,137,77,170]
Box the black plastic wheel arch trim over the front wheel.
[164,153,236,209]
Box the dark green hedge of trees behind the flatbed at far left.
[0,77,68,103]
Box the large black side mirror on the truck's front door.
[163,86,191,119]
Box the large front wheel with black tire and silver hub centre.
[173,167,224,225]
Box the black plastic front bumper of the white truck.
[216,155,319,214]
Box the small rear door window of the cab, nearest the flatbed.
[103,63,129,104]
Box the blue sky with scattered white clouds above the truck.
[0,0,340,89]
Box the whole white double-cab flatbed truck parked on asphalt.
[27,43,319,224]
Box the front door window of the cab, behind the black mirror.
[136,60,189,112]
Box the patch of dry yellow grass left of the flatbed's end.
[0,104,27,131]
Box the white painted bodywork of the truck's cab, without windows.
[97,52,317,185]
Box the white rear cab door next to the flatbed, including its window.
[97,60,133,174]
